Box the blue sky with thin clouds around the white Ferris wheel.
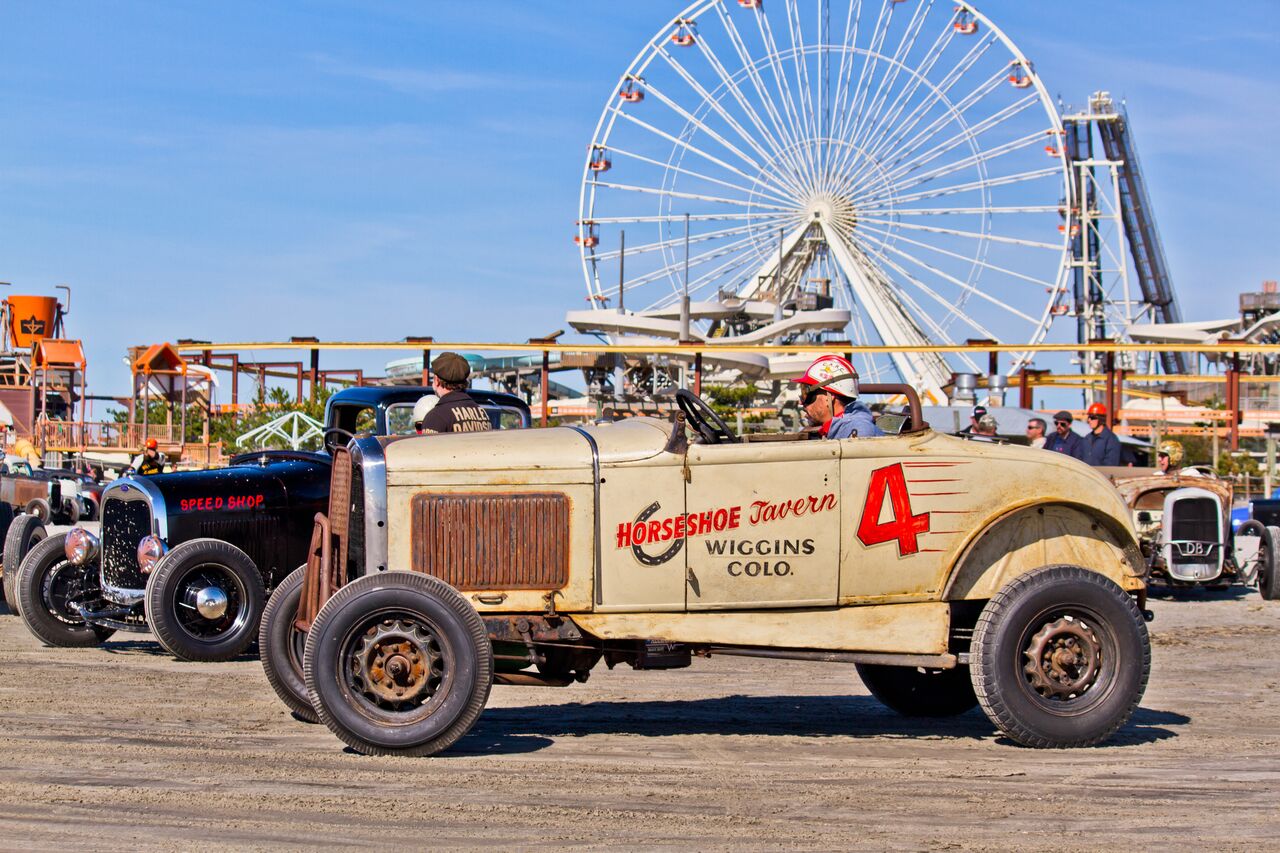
[0,0,1280,402]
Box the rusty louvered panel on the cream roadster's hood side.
[410,492,570,589]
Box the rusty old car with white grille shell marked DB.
[1103,467,1280,599]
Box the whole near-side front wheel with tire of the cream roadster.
[302,571,493,756]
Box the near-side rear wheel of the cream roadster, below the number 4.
[969,566,1151,748]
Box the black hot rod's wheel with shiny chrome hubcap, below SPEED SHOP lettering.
[147,539,266,661]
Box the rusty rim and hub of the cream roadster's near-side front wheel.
[351,619,444,708]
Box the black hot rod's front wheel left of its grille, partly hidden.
[15,533,115,648]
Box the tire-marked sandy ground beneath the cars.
[0,592,1280,850]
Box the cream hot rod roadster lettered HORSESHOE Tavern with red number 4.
[260,386,1151,754]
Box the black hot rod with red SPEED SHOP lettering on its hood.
[13,387,529,661]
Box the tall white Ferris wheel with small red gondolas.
[575,0,1071,393]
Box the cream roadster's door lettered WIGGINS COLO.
[685,441,844,610]
